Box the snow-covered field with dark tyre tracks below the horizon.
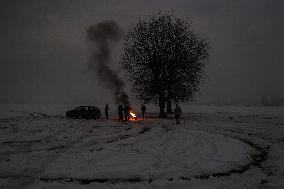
[0,105,284,189]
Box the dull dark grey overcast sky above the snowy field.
[0,0,284,103]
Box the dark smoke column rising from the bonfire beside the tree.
[87,20,129,104]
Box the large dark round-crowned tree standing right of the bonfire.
[120,13,208,117]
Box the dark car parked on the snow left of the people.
[66,106,101,119]
